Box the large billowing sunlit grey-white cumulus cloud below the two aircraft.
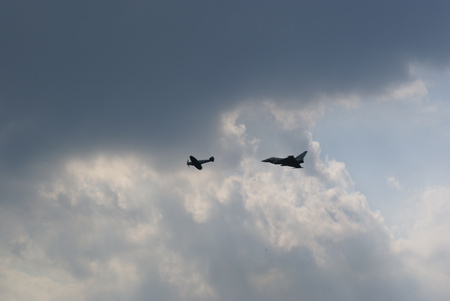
[0,102,446,300]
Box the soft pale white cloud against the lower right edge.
[396,186,450,300]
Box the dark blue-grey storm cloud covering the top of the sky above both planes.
[0,1,450,168]
